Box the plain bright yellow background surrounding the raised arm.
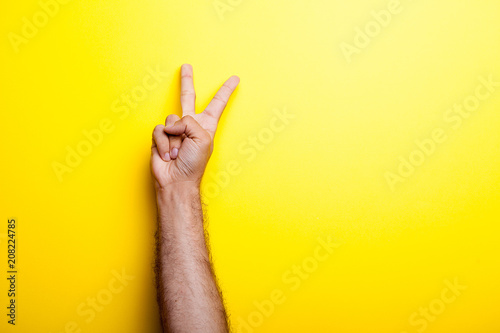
[0,0,500,333]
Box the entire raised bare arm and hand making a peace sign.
[151,64,240,333]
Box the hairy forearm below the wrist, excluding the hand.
[157,183,228,333]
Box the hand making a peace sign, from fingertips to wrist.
[151,64,240,189]
